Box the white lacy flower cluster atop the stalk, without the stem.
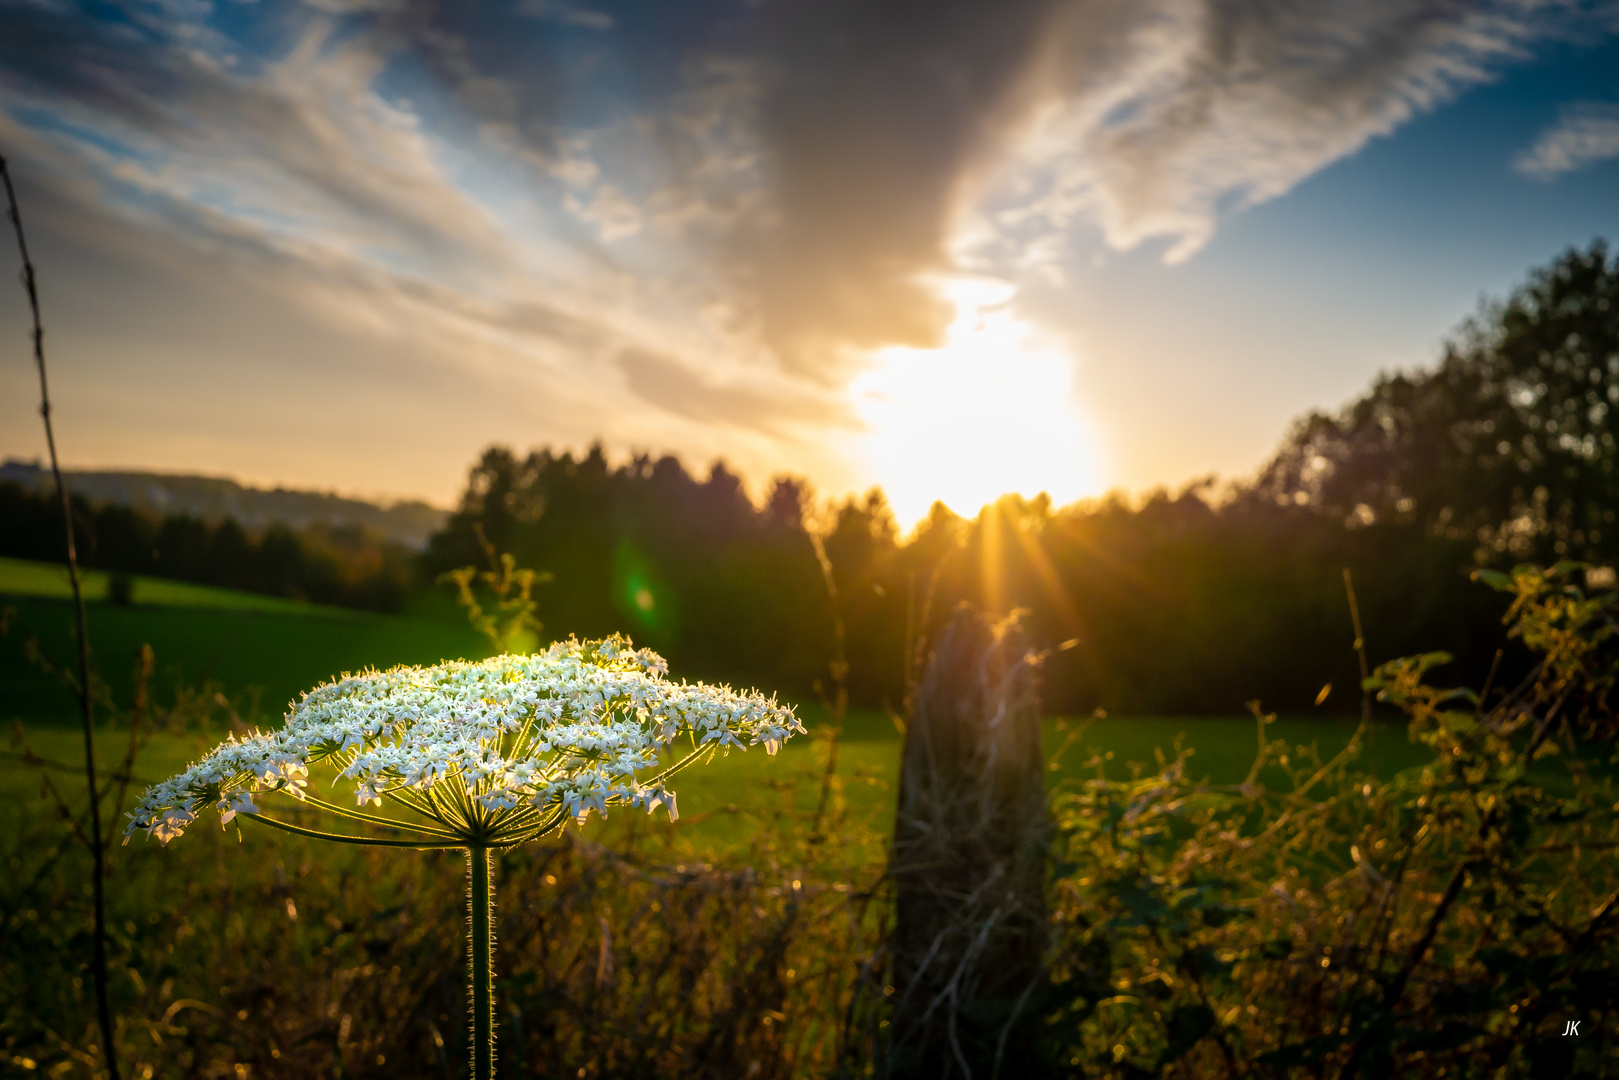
[126,635,805,844]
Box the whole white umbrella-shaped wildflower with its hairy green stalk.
[125,636,803,1080]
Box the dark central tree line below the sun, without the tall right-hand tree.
[424,447,1504,714]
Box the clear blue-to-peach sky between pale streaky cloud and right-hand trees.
[1031,26,1619,501]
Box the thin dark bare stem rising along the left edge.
[0,155,118,1080]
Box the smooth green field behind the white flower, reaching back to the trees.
[0,559,1423,845]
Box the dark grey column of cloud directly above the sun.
[748,0,1056,356]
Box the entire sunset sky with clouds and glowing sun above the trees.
[0,0,1619,525]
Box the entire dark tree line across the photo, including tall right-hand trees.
[0,241,1619,714]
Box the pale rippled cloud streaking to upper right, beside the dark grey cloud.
[964,0,1583,262]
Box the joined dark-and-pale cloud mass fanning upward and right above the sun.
[740,0,1595,364]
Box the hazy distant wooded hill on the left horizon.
[0,458,448,551]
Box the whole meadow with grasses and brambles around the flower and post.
[0,562,1619,1080]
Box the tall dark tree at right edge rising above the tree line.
[1258,240,1619,562]
